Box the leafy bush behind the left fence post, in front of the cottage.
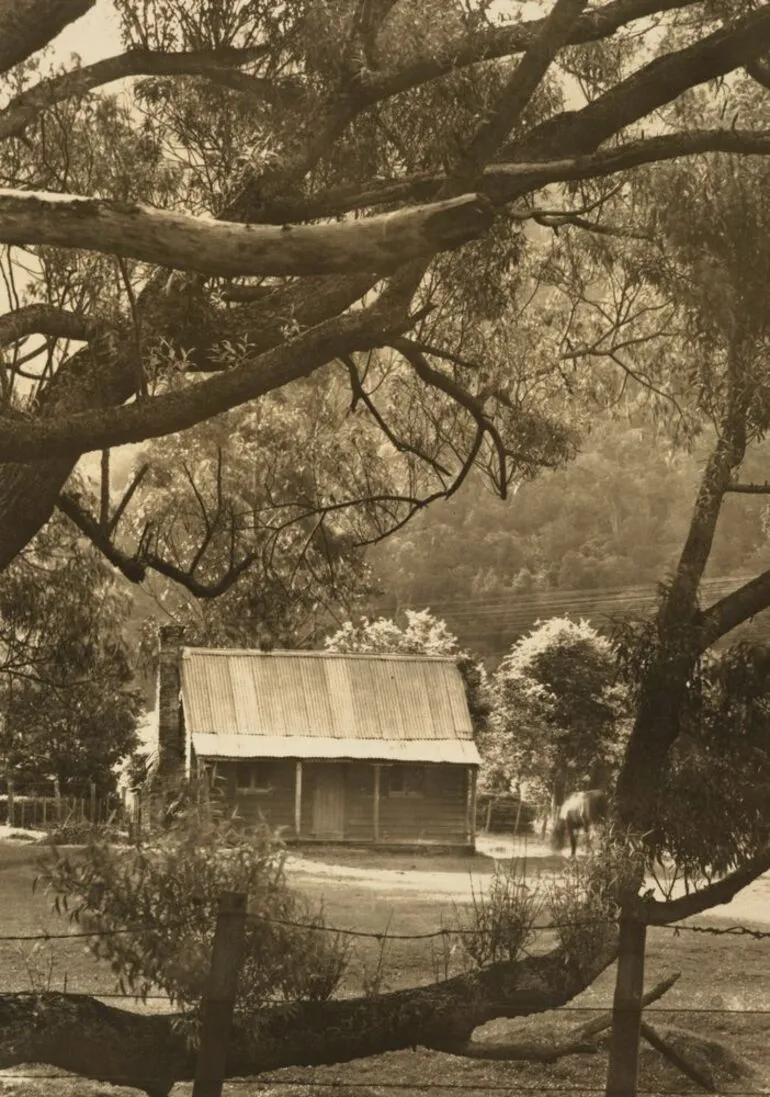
[41,804,348,1010]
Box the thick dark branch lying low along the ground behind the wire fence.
[0,935,618,1097]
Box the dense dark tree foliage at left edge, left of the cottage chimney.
[0,509,141,795]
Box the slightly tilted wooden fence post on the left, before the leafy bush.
[192,892,247,1097]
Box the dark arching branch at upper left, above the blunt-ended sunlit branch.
[0,45,287,140]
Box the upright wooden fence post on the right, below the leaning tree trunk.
[605,914,647,1097]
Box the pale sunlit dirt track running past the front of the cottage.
[287,835,770,926]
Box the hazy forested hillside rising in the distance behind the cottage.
[369,417,770,658]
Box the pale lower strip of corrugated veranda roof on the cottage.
[192,732,482,766]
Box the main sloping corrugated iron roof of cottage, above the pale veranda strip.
[181,647,473,760]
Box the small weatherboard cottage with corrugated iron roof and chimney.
[159,626,480,849]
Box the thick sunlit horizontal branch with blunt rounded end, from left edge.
[0,190,492,278]
